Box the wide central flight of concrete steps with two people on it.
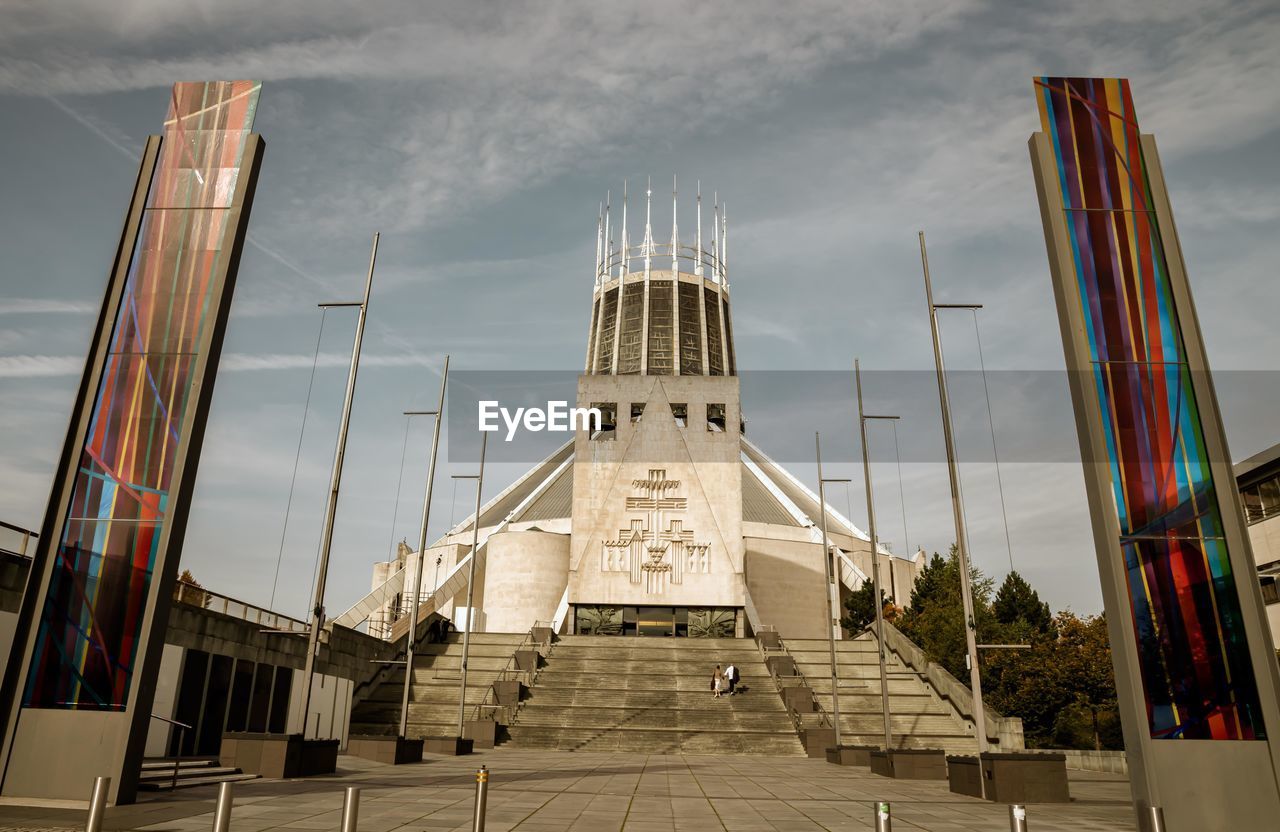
[508,636,804,756]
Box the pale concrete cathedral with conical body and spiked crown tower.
[360,188,923,639]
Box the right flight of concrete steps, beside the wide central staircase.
[783,634,974,754]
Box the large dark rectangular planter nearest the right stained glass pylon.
[947,751,1071,803]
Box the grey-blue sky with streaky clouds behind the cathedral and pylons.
[0,0,1280,616]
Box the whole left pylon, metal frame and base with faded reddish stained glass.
[0,81,264,803]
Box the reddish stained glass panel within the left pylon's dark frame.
[23,81,261,710]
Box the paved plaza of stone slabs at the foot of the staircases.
[0,749,1134,832]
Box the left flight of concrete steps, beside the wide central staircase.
[351,632,526,737]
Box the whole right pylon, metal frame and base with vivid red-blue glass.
[1030,78,1280,829]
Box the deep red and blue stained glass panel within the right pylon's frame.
[1034,78,1266,740]
